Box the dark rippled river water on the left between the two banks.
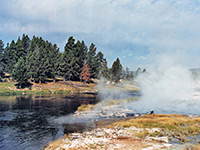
[0,94,98,150]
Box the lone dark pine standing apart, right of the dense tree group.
[112,58,122,83]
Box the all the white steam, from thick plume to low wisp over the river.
[54,56,200,124]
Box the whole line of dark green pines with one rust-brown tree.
[0,34,133,87]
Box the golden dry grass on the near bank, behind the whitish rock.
[107,114,200,140]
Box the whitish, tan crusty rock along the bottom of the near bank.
[46,127,172,150]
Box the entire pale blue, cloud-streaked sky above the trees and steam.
[0,0,200,70]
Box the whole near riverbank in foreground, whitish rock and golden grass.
[45,115,200,150]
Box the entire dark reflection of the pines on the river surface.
[10,96,99,140]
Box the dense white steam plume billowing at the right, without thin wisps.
[126,57,200,115]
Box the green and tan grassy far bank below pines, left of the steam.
[0,81,96,96]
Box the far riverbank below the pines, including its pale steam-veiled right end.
[0,79,139,96]
